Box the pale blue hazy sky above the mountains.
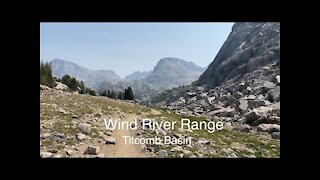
[40,23,234,77]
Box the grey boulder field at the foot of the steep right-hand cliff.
[162,61,280,139]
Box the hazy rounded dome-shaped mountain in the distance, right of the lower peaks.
[145,57,203,89]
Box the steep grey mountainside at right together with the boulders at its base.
[151,23,280,141]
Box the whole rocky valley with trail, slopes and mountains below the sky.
[40,22,281,158]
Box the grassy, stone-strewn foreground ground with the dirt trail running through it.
[40,81,280,158]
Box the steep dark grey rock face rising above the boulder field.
[197,23,280,87]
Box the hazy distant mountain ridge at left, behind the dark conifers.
[51,59,121,87]
